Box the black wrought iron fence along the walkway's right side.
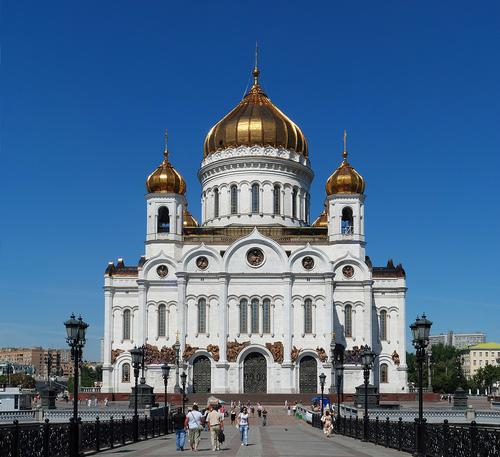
[311,413,500,457]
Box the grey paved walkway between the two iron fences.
[96,407,410,457]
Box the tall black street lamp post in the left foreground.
[64,314,89,457]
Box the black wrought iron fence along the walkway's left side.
[0,410,173,457]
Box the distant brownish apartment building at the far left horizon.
[0,347,71,379]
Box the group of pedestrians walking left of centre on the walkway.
[173,402,268,452]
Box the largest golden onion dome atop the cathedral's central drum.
[204,67,308,157]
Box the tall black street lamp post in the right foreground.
[410,314,432,457]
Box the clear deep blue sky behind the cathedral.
[0,0,500,359]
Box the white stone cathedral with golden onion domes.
[102,67,407,394]
